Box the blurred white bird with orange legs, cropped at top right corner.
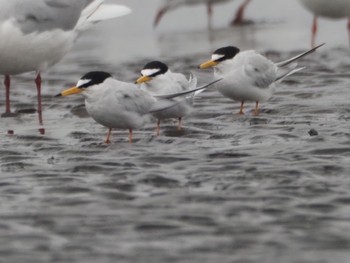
[299,0,350,47]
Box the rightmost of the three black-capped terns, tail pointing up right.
[199,44,324,115]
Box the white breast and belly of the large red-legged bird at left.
[0,20,77,74]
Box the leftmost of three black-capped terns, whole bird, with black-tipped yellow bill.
[56,71,219,143]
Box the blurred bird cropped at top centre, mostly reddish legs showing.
[153,0,251,28]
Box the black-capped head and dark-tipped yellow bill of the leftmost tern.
[56,71,112,96]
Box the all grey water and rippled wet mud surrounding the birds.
[0,0,350,263]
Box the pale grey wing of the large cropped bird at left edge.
[0,0,92,34]
